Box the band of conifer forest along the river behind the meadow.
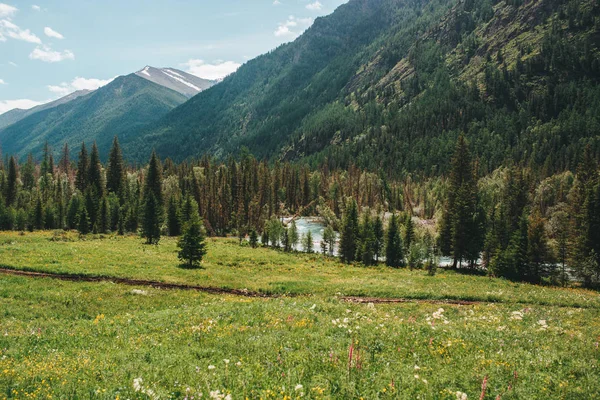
[0,136,600,287]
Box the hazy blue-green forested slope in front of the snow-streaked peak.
[0,74,187,158]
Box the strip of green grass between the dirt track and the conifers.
[0,232,600,308]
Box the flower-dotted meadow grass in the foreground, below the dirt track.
[0,276,600,399]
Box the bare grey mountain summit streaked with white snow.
[135,66,217,97]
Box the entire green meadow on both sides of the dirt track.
[0,232,600,399]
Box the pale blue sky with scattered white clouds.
[0,0,347,114]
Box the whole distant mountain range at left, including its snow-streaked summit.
[0,67,216,158]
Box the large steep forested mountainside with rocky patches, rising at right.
[124,0,600,174]
